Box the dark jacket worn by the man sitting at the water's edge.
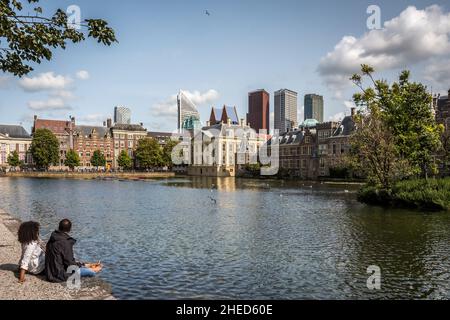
[45,231,81,282]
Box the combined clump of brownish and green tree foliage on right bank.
[351,65,443,187]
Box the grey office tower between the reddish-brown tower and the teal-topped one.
[274,89,298,134]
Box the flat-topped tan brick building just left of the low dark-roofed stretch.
[111,124,147,168]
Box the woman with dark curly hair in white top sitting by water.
[18,221,45,283]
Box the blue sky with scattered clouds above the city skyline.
[0,0,450,131]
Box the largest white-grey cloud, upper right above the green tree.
[318,5,450,97]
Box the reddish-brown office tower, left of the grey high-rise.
[247,89,270,133]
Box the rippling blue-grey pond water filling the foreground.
[0,178,450,299]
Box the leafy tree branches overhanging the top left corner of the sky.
[0,0,117,76]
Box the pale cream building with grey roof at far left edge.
[0,125,33,167]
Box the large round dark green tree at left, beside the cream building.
[30,129,59,169]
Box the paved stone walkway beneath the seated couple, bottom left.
[0,209,114,300]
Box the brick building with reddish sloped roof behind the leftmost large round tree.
[32,116,76,169]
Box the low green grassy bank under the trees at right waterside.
[358,178,450,211]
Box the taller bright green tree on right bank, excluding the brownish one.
[351,65,443,182]
